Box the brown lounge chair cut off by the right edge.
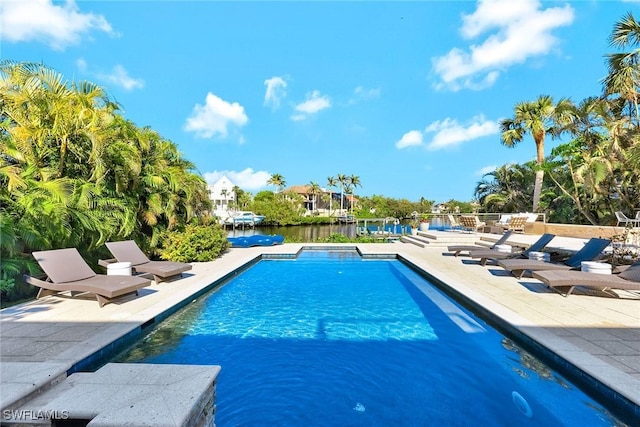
[532,261,640,297]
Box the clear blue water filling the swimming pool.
[116,251,623,427]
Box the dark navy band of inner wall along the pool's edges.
[82,246,638,422]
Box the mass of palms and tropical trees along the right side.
[475,14,640,225]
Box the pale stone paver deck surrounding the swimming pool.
[0,234,640,425]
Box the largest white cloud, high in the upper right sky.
[433,0,574,90]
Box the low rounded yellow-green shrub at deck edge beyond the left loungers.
[159,225,229,262]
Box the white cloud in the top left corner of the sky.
[0,0,113,50]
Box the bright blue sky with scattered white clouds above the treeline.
[0,0,640,202]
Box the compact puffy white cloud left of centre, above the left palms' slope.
[184,92,249,138]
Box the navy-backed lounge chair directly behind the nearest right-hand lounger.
[498,237,611,278]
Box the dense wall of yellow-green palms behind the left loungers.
[0,61,215,300]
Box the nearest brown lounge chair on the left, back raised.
[24,248,151,307]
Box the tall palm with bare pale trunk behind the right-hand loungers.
[500,95,573,212]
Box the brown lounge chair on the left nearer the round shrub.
[100,240,191,283]
